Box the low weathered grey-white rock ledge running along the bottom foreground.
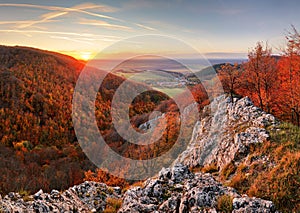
[0,164,275,213]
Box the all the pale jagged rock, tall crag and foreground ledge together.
[0,96,278,213]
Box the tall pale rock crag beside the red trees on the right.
[175,96,278,169]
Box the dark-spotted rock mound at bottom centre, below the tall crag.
[119,164,275,213]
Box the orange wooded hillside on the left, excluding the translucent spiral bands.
[0,46,176,193]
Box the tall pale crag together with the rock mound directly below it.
[120,96,279,212]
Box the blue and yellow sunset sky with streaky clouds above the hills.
[0,0,300,60]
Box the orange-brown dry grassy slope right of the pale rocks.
[220,123,300,212]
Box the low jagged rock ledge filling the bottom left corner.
[0,181,121,213]
